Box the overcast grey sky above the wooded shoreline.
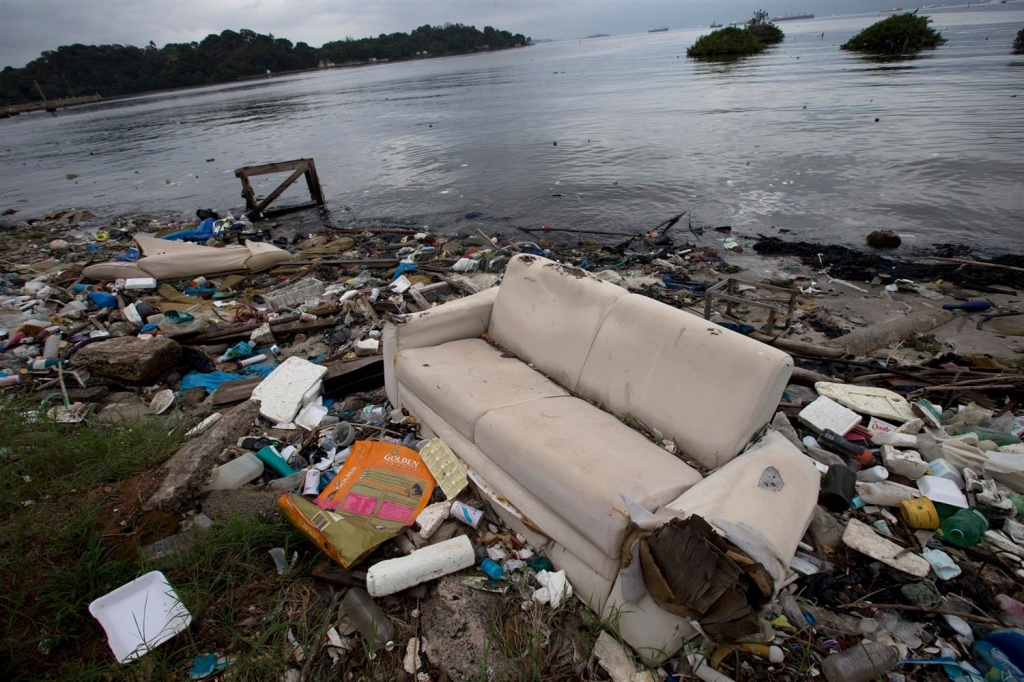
[0,0,915,68]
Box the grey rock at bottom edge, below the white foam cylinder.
[423,573,509,680]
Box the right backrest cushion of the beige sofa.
[577,294,793,468]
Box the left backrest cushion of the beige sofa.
[487,255,626,391]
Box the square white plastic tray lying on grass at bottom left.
[89,570,191,664]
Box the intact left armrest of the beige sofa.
[384,287,499,409]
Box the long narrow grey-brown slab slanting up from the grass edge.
[145,400,259,514]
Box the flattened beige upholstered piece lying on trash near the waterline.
[82,236,292,280]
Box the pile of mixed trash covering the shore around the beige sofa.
[0,204,1024,682]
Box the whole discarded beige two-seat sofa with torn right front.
[384,255,819,662]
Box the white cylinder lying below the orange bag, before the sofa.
[367,536,476,597]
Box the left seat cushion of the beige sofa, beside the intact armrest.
[394,339,567,440]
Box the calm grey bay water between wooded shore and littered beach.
[0,3,1024,246]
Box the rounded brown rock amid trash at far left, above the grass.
[71,336,181,384]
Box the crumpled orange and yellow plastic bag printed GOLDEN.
[278,440,434,568]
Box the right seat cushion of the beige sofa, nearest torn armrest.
[474,397,700,556]
